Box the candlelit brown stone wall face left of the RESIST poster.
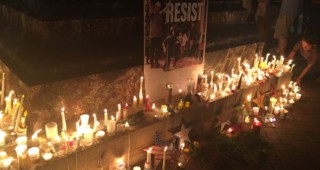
[1,61,143,134]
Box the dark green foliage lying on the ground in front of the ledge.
[190,131,268,169]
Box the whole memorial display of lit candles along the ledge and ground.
[0,55,301,169]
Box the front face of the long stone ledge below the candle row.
[25,73,292,170]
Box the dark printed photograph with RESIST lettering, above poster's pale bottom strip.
[144,0,207,72]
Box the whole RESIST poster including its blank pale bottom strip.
[144,0,208,101]
